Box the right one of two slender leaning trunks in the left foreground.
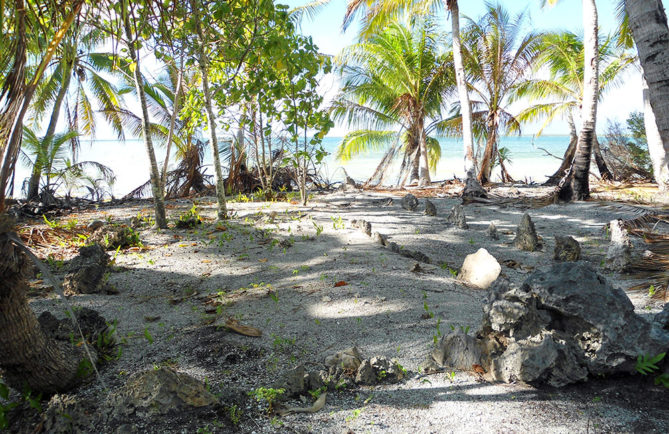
[191,0,228,220]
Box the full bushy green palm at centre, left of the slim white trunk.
[332,21,453,185]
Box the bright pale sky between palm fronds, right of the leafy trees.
[277,0,669,136]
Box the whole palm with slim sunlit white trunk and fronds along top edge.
[344,0,475,178]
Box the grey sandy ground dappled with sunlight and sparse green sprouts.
[13,190,669,433]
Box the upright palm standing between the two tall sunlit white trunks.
[447,4,541,183]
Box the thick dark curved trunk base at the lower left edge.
[0,216,83,395]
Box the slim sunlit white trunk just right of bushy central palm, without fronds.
[449,0,475,178]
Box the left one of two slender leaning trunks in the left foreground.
[123,1,167,229]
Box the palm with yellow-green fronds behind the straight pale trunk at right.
[512,32,635,185]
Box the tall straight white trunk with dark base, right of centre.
[560,0,599,200]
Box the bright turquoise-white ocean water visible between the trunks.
[15,136,569,197]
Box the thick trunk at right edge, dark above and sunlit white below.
[625,0,669,189]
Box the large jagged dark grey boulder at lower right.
[482,263,669,387]
